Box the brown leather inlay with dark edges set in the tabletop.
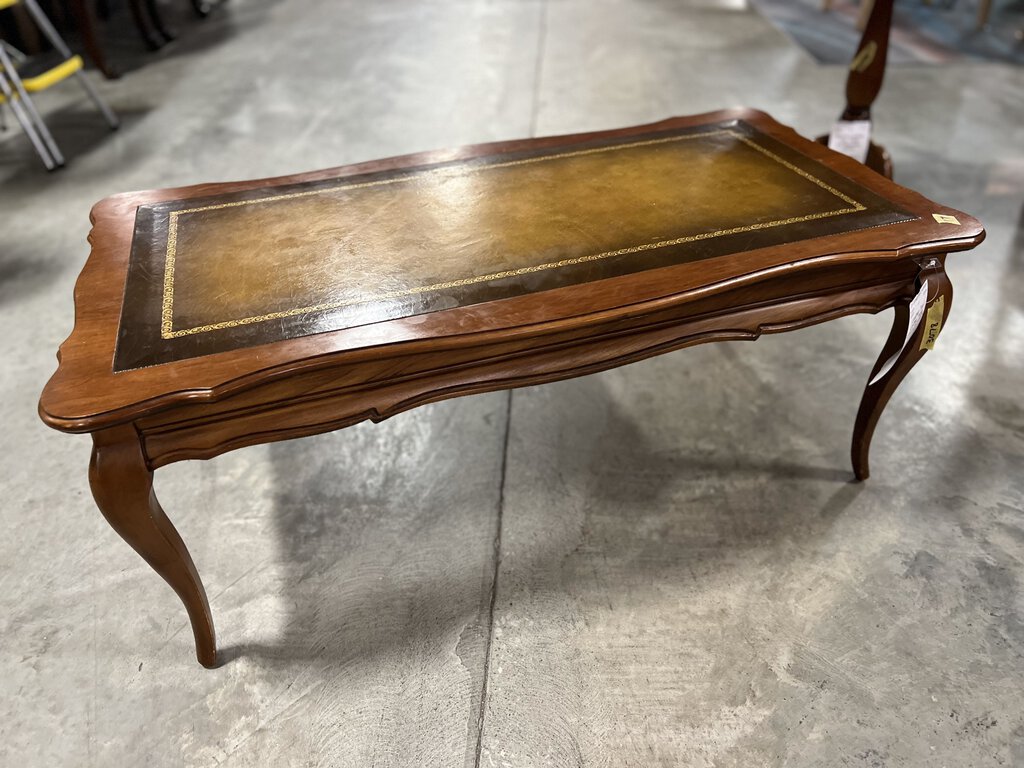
[115,121,913,370]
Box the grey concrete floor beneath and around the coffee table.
[0,0,1024,768]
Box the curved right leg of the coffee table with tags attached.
[851,257,953,480]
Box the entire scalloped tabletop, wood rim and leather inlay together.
[40,110,984,431]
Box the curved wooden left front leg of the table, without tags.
[89,425,217,668]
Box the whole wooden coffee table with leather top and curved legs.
[39,110,984,667]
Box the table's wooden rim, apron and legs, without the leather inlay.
[39,110,984,667]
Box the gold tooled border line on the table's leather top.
[160,128,865,339]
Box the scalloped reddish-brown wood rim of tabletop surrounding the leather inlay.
[40,110,983,431]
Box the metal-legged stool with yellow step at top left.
[0,0,119,171]
